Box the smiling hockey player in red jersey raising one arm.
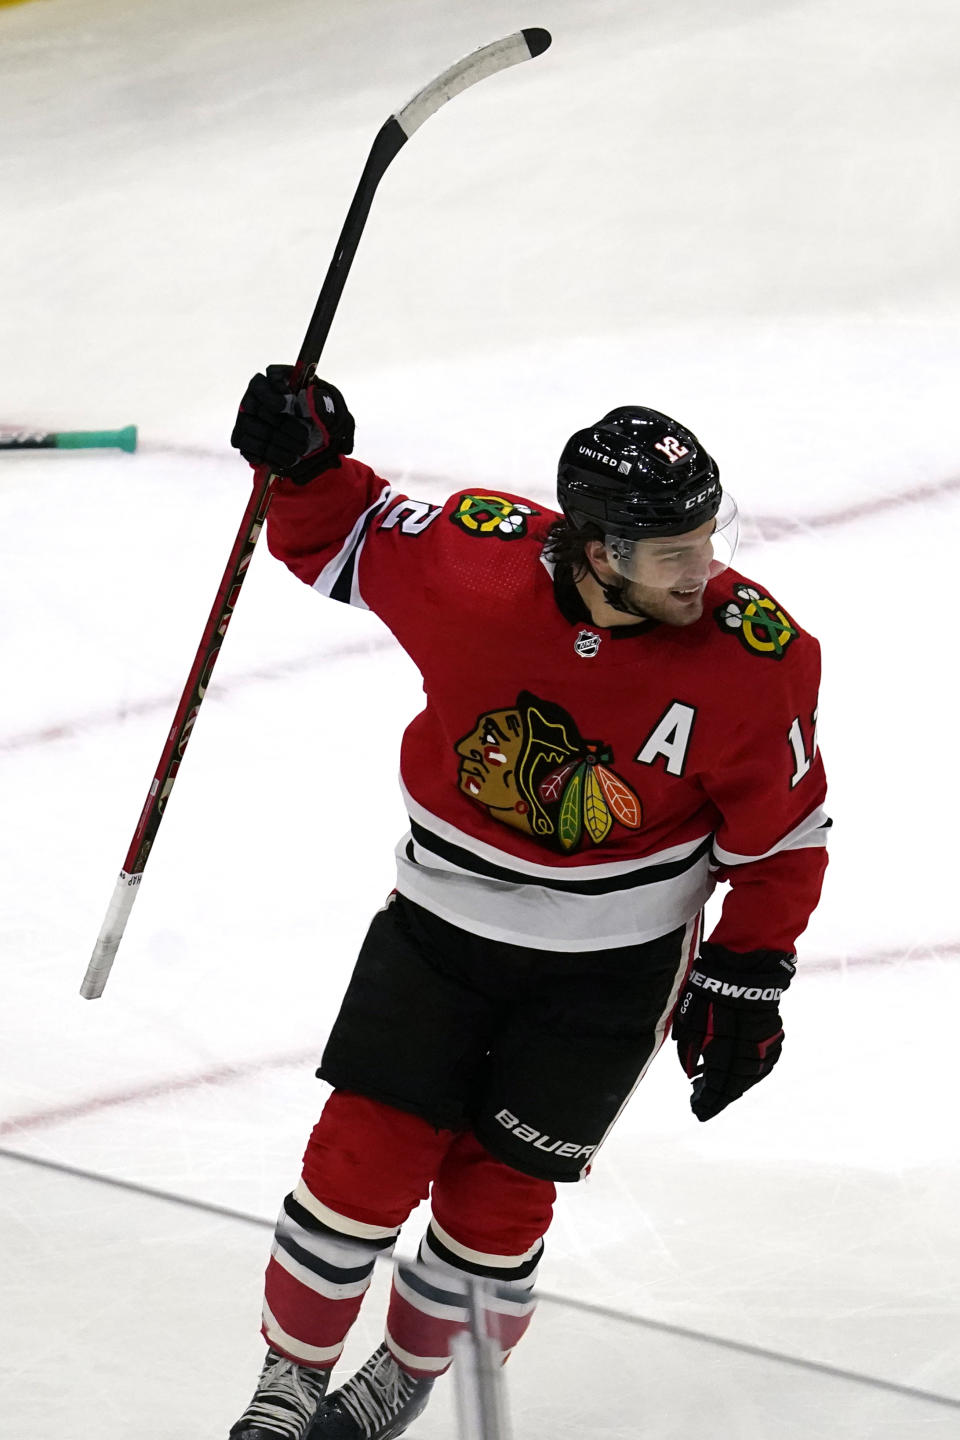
[230,366,829,1440]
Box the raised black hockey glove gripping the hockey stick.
[230,364,354,485]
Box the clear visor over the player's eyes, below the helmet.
[604,494,740,590]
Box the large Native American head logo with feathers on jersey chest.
[456,690,643,852]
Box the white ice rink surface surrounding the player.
[0,0,960,1440]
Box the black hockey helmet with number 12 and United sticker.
[557,405,723,540]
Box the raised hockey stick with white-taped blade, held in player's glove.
[81,29,550,999]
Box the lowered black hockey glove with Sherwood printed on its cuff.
[674,942,796,1120]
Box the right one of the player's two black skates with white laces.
[309,1345,433,1440]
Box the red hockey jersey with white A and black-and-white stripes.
[268,459,829,950]
